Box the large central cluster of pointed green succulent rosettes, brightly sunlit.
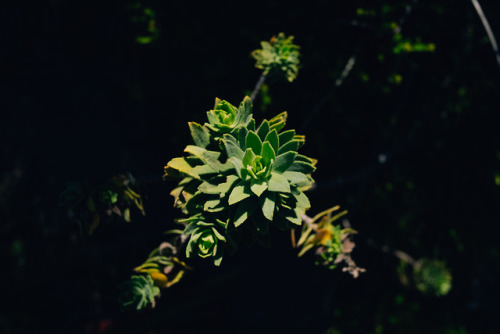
[164,97,316,265]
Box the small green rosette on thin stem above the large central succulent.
[251,33,300,82]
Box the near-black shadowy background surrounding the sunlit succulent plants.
[0,0,500,334]
